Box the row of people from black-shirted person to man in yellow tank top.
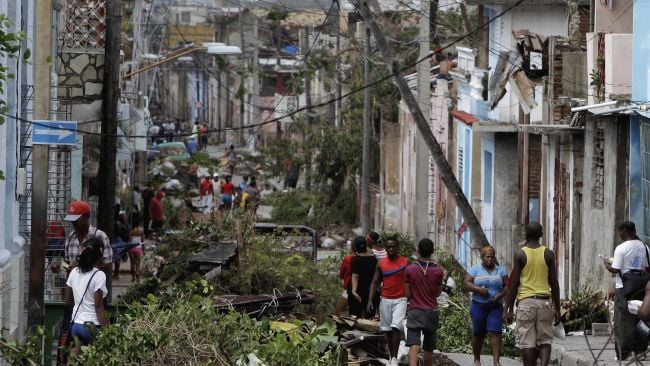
[336,222,560,366]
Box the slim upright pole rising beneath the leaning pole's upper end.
[359,22,370,235]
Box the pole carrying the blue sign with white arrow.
[27,0,52,330]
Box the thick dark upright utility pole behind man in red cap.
[97,0,122,243]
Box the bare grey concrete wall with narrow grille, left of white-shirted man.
[579,117,625,289]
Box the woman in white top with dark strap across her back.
[65,238,108,360]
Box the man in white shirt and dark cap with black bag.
[604,221,650,360]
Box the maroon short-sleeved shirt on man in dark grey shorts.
[405,262,444,309]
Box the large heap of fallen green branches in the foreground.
[74,281,341,366]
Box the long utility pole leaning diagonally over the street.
[352,0,489,248]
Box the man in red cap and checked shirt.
[64,201,113,273]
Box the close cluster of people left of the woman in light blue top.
[337,232,444,365]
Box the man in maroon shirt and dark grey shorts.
[406,239,444,366]
